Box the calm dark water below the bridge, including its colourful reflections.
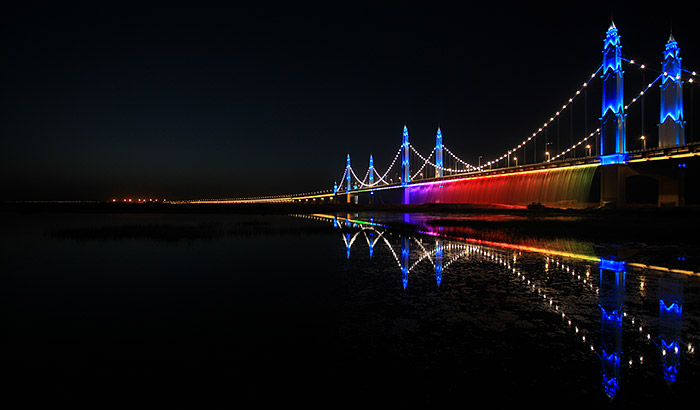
[0,213,700,408]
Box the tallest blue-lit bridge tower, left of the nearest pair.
[600,23,627,165]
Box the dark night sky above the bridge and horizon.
[0,2,700,200]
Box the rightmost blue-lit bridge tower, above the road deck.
[659,34,685,147]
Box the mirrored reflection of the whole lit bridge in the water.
[298,215,698,400]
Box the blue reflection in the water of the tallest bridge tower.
[600,259,625,398]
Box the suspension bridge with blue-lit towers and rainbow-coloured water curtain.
[198,22,700,208]
